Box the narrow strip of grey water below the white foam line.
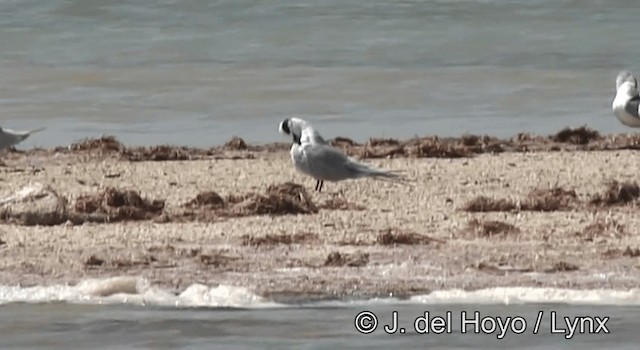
[0,304,640,350]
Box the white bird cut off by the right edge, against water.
[611,70,640,128]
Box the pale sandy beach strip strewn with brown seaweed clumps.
[0,130,640,299]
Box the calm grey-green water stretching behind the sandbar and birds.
[0,0,640,147]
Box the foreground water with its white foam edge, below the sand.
[0,277,640,349]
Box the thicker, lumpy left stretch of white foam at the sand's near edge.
[0,277,278,308]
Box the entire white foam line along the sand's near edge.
[0,277,640,308]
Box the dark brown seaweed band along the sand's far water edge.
[5,126,640,162]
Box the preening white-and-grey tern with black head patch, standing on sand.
[279,118,403,192]
